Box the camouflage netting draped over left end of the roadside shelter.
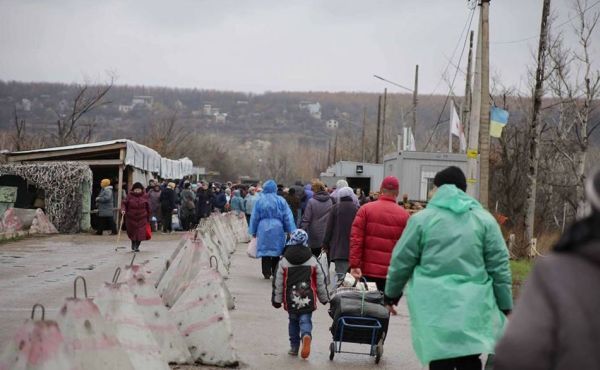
[0,162,92,233]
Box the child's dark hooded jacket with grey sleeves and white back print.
[273,245,329,314]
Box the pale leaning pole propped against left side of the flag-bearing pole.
[466,0,489,199]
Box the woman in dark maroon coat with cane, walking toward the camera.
[121,182,152,252]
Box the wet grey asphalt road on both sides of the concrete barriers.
[0,233,422,370]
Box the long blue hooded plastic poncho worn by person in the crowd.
[248,180,296,258]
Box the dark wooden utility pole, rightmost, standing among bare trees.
[525,0,550,251]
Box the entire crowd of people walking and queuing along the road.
[96,167,600,370]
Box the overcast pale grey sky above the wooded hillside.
[0,0,600,94]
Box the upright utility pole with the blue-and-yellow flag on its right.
[479,0,490,208]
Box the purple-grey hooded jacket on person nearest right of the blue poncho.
[300,191,333,248]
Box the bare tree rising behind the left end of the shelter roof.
[53,76,114,146]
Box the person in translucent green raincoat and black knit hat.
[385,167,512,369]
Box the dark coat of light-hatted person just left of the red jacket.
[323,197,358,261]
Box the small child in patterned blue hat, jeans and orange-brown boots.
[272,229,329,358]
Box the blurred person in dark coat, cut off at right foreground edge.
[494,171,600,370]
